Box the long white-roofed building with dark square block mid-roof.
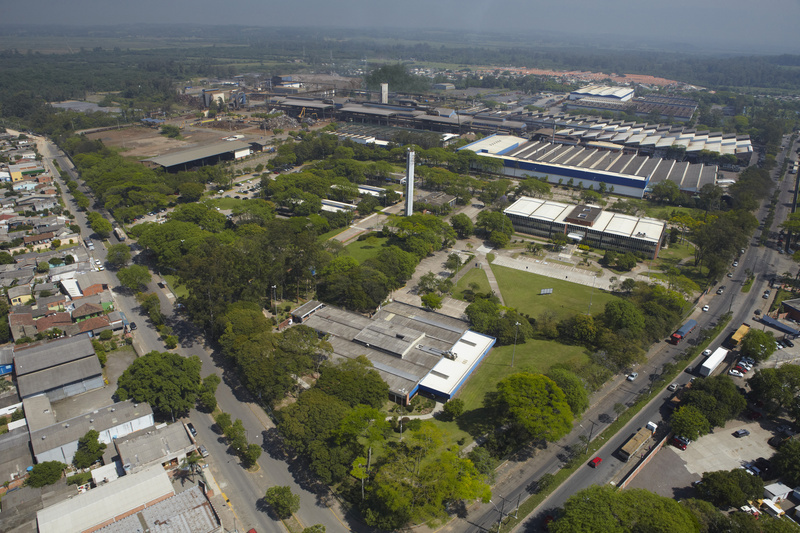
[503,196,667,258]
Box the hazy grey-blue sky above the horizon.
[6,0,800,54]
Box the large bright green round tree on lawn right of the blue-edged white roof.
[485,372,573,442]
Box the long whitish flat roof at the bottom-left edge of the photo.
[36,465,175,533]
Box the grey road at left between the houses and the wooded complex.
[40,138,359,533]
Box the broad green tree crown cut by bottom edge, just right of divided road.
[548,485,697,533]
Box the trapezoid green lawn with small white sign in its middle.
[492,265,616,319]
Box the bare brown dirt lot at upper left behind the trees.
[87,126,225,159]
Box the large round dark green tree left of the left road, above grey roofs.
[116,351,201,420]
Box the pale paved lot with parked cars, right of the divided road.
[629,420,775,498]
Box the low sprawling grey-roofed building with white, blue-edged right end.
[298,302,495,404]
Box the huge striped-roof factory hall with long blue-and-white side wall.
[459,135,717,198]
